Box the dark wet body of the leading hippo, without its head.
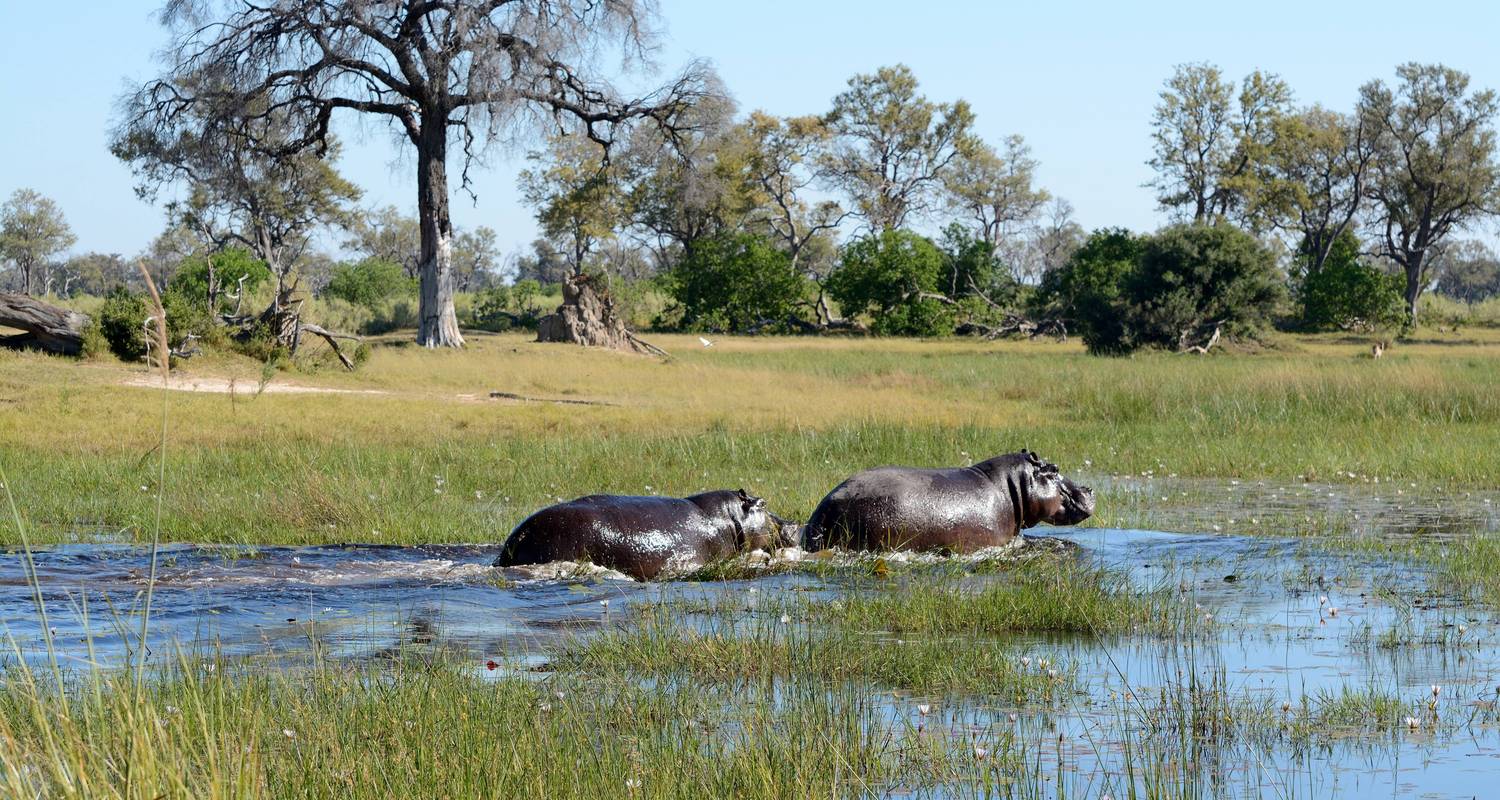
[804,467,1011,549]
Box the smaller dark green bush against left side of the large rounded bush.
[1032,228,1146,354]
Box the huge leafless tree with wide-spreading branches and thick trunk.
[134,0,704,347]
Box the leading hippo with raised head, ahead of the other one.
[803,450,1094,552]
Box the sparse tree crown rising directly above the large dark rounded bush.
[1148,65,1292,227]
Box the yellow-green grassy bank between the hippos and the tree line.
[0,332,1500,543]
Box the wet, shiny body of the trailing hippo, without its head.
[495,494,714,578]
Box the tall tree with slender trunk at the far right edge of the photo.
[1359,63,1500,324]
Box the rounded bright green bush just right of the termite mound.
[666,234,807,332]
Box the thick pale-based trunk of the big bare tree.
[417,114,464,347]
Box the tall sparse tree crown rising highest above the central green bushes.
[824,65,975,233]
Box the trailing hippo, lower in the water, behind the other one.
[495,489,797,581]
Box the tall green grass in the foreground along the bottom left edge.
[0,648,1019,800]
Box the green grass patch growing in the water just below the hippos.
[557,557,1199,704]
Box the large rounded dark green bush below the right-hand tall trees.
[1125,222,1283,351]
